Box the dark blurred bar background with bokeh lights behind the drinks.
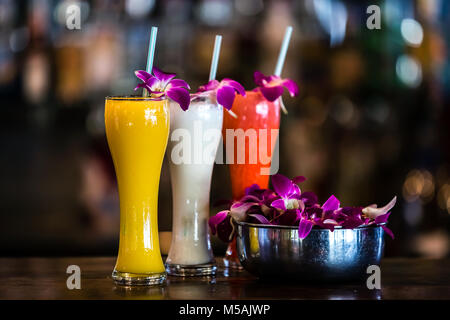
[0,0,450,258]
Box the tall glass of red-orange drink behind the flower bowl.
[223,91,280,269]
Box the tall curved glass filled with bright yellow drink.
[105,96,170,285]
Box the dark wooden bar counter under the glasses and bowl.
[0,257,450,300]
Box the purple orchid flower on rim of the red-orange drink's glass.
[253,71,299,102]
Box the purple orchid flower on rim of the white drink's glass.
[197,78,245,110]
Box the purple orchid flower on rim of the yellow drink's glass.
[134,67,191,111]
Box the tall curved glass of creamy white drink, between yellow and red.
[166,96,223,276]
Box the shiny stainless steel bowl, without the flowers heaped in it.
[236,222,384,282]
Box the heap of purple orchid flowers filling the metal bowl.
[209,174,396,242]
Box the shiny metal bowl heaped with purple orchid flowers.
[209,174,396,282]
